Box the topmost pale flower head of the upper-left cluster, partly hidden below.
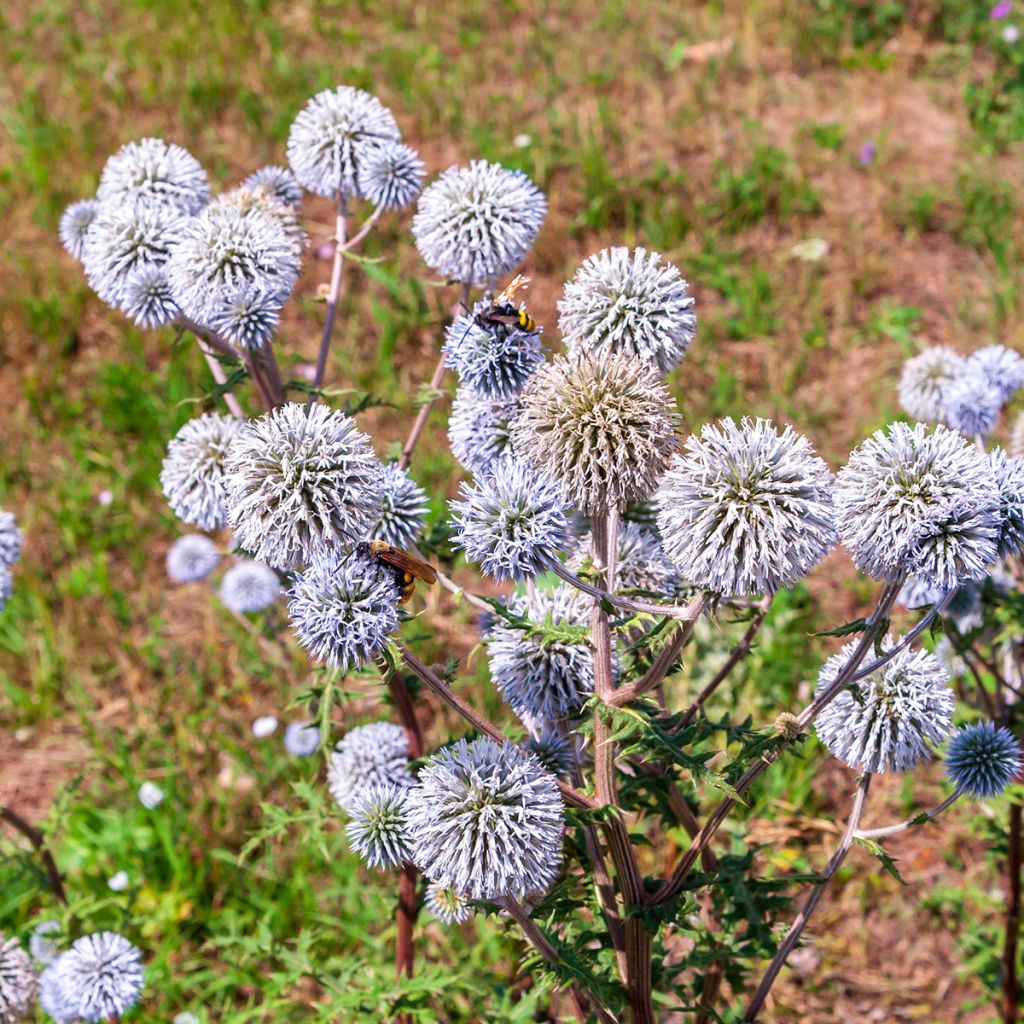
[96,138,210,216]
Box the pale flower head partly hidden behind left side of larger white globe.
[160,413,243,529]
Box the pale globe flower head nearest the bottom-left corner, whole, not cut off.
[57,932,142,1024]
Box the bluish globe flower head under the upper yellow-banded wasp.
[442,301,544,400]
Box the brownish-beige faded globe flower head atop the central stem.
[512,353,678,515]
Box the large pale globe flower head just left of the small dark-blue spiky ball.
[814,637,955,775]
